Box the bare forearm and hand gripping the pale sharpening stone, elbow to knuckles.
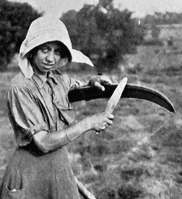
[33,112,114,153]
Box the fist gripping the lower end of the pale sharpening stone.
[90,112,114,132]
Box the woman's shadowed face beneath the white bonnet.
[32,41,63,75]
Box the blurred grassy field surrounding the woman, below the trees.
[0,45,182,199]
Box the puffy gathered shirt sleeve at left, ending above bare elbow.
[7,86,49,146]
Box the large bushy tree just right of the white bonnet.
[62,3,144,70]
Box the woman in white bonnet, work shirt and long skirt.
[0,17,114,199]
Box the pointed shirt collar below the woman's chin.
[32,71,58,88]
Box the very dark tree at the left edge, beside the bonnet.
[0,0,41,71]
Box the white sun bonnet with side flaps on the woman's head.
[18,16,93,78]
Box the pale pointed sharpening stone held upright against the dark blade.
[105,77,128,113]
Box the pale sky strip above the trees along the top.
[9,0,182,17]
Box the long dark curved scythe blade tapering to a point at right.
[68,84,175,113]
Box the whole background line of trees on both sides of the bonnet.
[0,0,182,72]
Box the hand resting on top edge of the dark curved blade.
[89,75,112,91]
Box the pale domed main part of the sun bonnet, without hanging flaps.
[20,16,72,56]
